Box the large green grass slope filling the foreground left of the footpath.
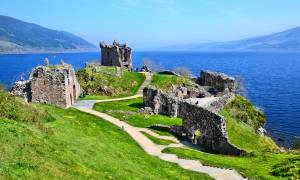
[0,102,211,179]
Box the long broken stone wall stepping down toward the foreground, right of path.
[143,87,243,155]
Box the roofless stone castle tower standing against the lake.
[100,41,133,70]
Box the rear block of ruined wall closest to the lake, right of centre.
[198,70,237,92]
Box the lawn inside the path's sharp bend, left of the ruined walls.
[94,98,182,127]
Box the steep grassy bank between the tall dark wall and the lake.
[220,96,279,152]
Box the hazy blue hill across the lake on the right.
[165,27,300,51]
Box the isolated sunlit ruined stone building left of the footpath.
[11,64,80,108]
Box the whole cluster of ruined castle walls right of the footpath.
[143,71,244,155]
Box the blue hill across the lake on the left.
[0,15,96,53]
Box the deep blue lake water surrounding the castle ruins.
[0,52,300,146]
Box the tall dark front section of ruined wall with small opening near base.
[180,102,243,155]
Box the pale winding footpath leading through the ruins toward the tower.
[73,73,245,180]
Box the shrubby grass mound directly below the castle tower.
[76,66,145,99]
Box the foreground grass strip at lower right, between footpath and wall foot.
[163,148,299,179]
